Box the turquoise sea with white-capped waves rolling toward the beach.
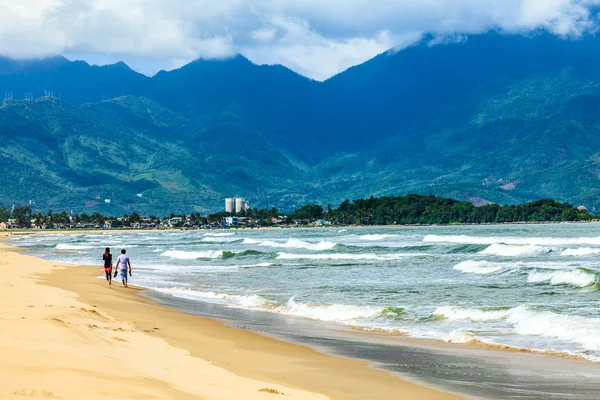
[13,224,600,361]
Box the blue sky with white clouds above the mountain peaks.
[0,0,600,80]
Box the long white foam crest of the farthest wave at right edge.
[423,235,600,246]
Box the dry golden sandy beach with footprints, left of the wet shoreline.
[0,234,459,400]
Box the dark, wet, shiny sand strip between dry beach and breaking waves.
[144,291,600,400]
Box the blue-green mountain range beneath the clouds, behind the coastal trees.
[0,33,600,214]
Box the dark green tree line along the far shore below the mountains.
[0,194,598,228]
